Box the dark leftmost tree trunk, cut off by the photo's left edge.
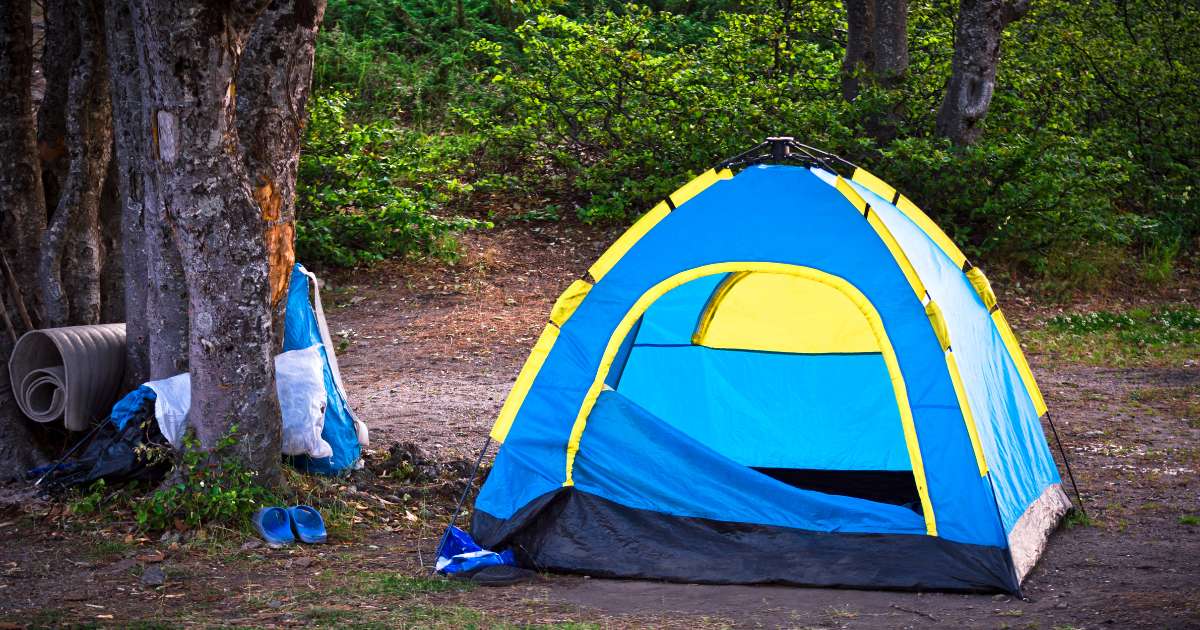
[0,1,46,479]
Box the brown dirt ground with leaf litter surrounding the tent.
[0,223,1200,630]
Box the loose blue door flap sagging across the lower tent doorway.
[573,391,925,534]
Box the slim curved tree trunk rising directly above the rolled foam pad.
[38,0,112,326]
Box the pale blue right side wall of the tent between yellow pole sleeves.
[840,171,1061,532]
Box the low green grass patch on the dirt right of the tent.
[1024,305,1200,367]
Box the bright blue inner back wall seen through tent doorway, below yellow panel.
[617,343,912,470]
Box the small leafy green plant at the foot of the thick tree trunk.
[134,426,277,530]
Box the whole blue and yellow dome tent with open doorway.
[472,138,1070,593]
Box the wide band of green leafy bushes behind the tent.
[309,0,1200,274]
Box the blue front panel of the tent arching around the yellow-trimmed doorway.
[478,166,1003,546]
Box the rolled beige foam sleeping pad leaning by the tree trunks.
[8,324,125,431]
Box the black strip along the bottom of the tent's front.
[472,487,1020,593]
